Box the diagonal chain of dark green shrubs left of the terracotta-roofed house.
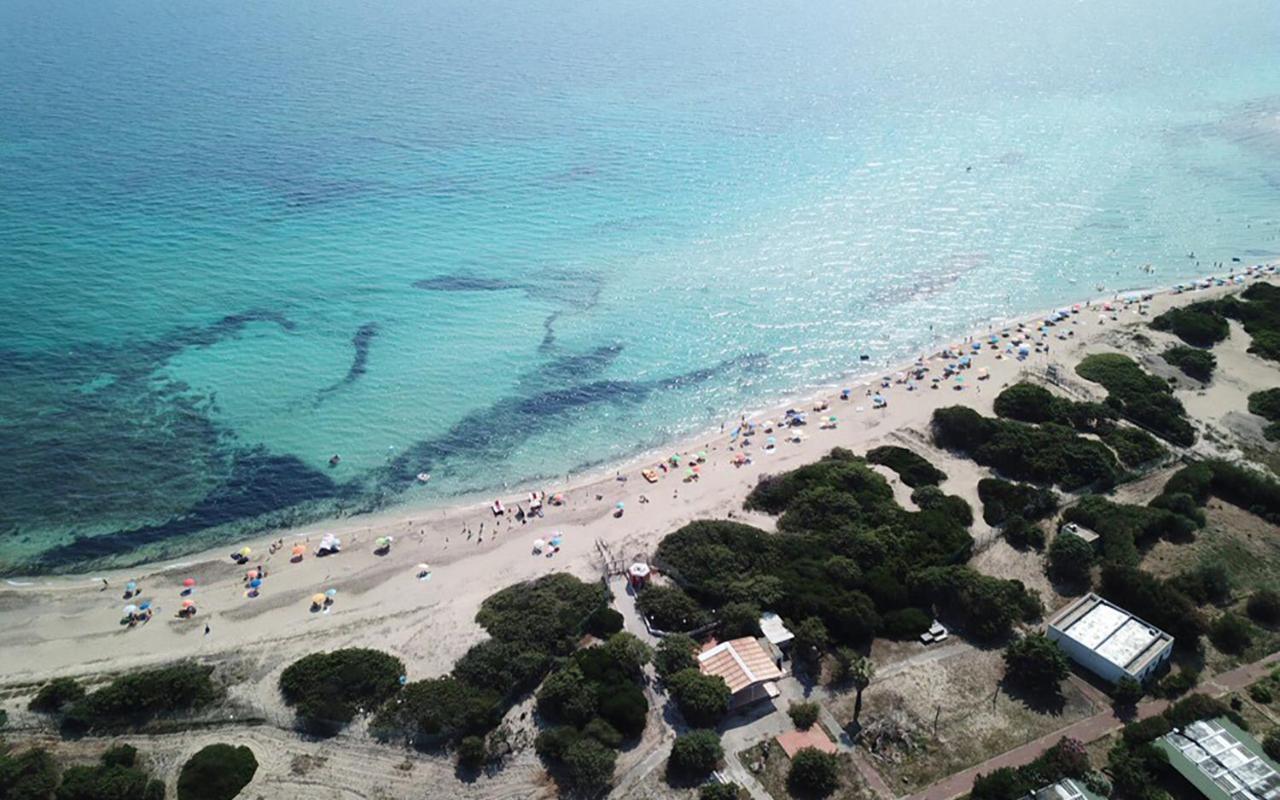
[370,572,612,747]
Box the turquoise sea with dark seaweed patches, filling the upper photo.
[0,0,1280,573]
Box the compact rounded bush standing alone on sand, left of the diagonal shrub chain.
[280,648,404,735]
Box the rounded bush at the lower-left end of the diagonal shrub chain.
[370,677,502,745]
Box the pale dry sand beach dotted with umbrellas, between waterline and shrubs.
[0,268,1275,685]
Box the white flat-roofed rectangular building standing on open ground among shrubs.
[1048,593,1174,684]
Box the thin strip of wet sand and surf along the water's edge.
[0,261,1280,591]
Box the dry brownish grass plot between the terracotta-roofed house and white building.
[832,650,1101,794]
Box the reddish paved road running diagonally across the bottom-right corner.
[909,652,1280,800]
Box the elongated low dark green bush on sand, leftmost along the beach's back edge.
[63,662,218,732]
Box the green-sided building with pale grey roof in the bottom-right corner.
[1156,717,1280,800]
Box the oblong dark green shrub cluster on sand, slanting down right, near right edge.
[1075,353,1196,447]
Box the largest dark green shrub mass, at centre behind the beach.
[641,448,1036,642]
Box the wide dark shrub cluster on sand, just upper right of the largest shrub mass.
[933,406,1120,492]
